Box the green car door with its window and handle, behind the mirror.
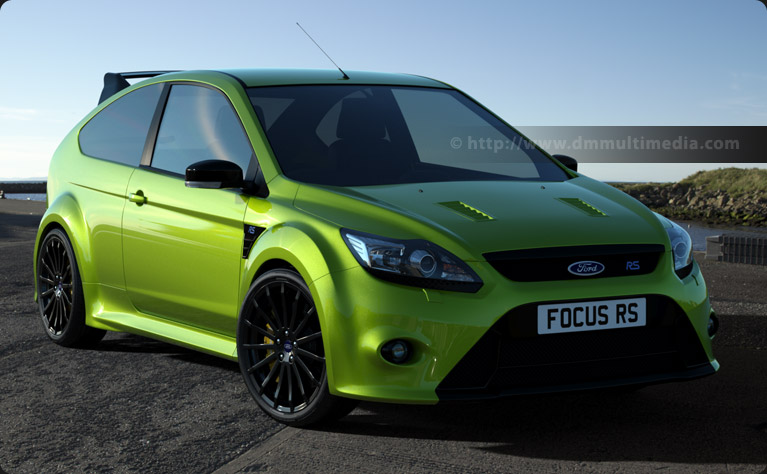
[122,84,257,336]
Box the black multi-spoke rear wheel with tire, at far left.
[37,229,106,347]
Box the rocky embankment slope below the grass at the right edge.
[613,181,767,226]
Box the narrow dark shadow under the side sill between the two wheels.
[88,333,240,372]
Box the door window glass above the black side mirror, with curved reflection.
[152,84,253,177]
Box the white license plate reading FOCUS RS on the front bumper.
[538,298,647,334]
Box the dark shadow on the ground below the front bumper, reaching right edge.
[316,342,767,465]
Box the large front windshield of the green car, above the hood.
[248,85,567,186]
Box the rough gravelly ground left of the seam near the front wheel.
[0,201,281,473]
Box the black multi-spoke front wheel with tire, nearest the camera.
[237,269,357,426]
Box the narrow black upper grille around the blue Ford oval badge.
[484,244,665,281]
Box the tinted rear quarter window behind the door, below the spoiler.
[79,84,162,166]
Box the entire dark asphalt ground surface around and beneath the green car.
[0,200,767,473]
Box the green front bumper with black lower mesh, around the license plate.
[310,254,718,403]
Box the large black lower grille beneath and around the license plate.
[437,295,708,398]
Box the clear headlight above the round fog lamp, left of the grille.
[341,229,482,293]
